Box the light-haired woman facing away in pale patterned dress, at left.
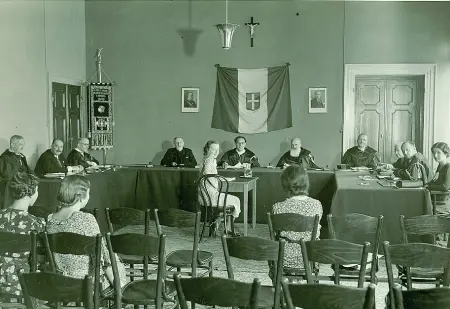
[47,175,126,291]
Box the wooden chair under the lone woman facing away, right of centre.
[267,213,320,280]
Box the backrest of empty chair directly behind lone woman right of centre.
[300,239,370,288]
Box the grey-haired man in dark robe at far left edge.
[0,135,33,208]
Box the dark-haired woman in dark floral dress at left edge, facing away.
[0,172,45,302]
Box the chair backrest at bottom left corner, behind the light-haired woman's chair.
[19,272,94,309]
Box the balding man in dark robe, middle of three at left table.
[34,139,82,177]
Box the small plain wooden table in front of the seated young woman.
[222,177,258,236]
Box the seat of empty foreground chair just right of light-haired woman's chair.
[122,280,176,305]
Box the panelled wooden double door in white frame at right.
[355,76,424,163]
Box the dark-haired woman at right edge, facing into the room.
[425,142,450,216]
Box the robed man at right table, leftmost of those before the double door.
[341,133,380,167]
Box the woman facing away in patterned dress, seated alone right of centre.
[269,165,323,279]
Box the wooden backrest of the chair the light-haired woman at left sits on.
[43,232,102,308]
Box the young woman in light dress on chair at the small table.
[198,140,241,235]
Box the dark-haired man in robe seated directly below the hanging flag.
[218,136,260,168]
